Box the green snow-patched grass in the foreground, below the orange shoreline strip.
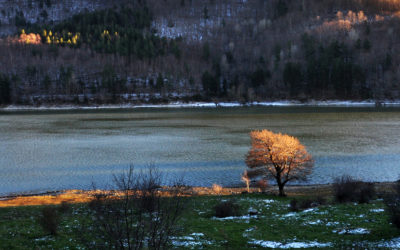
[0,194,400,249]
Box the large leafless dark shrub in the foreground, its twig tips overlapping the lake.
[82,166,188,249]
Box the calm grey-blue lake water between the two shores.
[0,107,400,195]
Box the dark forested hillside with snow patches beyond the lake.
[0,0,400,105]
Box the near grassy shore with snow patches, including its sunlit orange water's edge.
[0,183,400,249]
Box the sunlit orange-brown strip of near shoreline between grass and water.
[0,182,396,208]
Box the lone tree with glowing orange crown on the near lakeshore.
[246,130,314,196]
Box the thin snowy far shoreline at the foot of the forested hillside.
[0,100,400,111]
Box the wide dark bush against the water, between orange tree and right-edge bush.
[333,176,375,203]
